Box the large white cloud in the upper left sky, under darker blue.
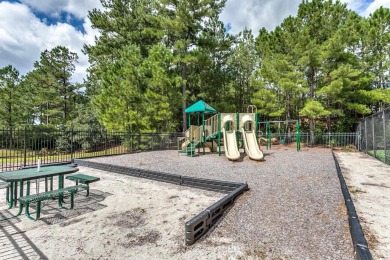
[0,2,97,82]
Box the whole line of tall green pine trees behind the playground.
[0,0,390,142]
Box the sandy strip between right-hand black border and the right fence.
[336,152,390,259]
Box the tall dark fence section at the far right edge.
[356,109,390,164]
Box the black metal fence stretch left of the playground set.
[0,129,182,171]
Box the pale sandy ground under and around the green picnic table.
[0,167,224,259]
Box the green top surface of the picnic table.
[0,166,79,182]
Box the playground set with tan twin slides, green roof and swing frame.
[178,100,300,161]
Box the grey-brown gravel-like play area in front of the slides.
[89,146,354,259]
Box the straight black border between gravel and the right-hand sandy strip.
[332,151,372,260]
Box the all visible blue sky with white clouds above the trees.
[0,0,390,82]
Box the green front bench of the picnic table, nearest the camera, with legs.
[19,185,88,221]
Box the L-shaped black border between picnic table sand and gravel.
[72,159,249,245]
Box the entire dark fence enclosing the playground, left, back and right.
[0,124,384,171]
